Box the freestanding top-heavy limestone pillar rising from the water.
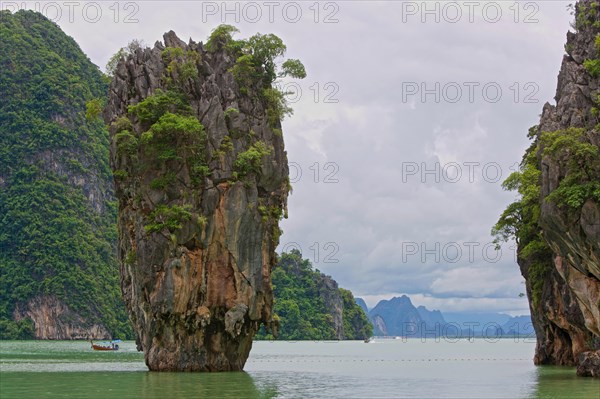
[105,32,289,371]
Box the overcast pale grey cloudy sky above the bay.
[8,1,572,314]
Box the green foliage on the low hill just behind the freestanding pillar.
[257,250,372,340]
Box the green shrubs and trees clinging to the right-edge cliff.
[492,126,600,308]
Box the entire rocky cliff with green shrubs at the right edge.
[494,0,600,376]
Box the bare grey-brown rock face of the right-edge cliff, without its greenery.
[519,0,600,376]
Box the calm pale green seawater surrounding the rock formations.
[0,338,600,399]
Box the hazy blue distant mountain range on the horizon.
[356,295,535,338]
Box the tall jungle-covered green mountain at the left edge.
[0,11,132,339]
